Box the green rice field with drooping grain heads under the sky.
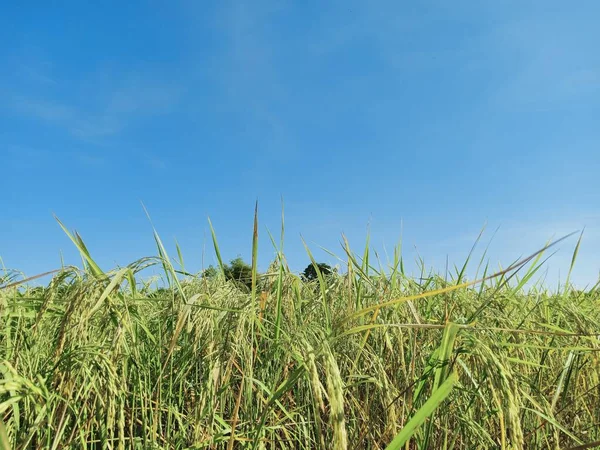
[0,218,600,450]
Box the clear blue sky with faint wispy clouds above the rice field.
[0,0,600,286]
